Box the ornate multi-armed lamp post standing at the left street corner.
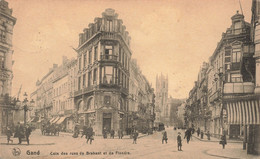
[16,92,35,125]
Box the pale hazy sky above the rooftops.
[7,0,252,98]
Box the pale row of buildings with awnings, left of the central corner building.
[31,56,77,131]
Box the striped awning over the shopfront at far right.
[226,98,260,125]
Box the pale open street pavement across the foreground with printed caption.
[0,128,257,159]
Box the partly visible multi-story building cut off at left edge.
[0,0,16,132]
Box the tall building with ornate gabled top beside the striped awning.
[208,12,255,138]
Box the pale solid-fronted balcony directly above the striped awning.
[224,82,255,94]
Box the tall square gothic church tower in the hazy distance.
[155,74,170,124]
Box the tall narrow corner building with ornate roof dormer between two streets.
[74,9,132,135]
